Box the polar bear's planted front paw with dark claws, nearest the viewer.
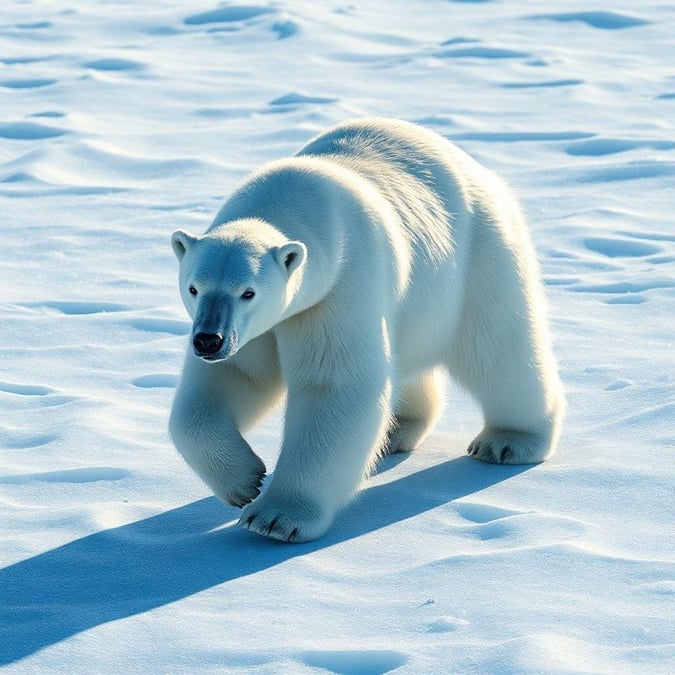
[239,491,332,544]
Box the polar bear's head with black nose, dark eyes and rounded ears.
[171,221,307,361]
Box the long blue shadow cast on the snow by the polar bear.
[0,456,530,666]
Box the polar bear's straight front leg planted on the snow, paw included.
[239,382,390,542]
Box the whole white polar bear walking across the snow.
[169,119,564,542]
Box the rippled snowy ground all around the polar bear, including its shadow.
[0,0,675,675]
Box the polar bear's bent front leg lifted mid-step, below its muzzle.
[169,355,280,507]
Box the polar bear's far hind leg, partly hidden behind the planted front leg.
[384,370,443,454]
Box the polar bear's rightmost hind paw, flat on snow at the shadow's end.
[466,429,550,464]
